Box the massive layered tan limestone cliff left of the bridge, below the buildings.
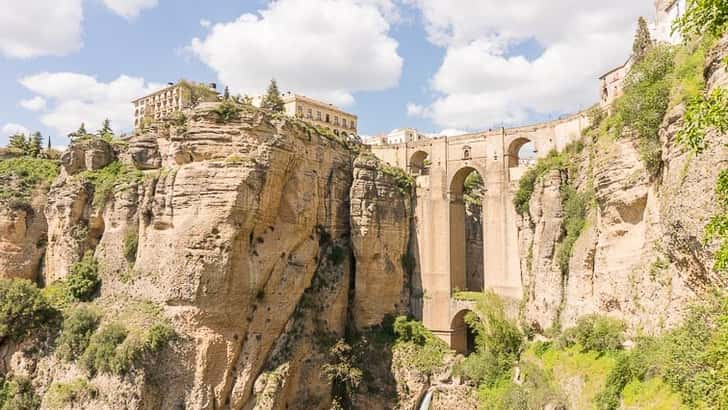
[0,104,410,409]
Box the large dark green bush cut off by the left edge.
[0,279,60,342]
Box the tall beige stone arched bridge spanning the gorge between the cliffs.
[371,112,589,353]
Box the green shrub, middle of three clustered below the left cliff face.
[80,323,129,375]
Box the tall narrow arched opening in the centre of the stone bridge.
[450,167,485,292]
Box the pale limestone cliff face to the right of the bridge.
[519,39,728,332]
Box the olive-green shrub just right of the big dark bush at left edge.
[57,306,101,361]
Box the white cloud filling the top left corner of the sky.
[0,0,83,58]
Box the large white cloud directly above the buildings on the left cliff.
[189,0,403,105]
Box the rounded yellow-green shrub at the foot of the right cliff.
[562,314,626,353]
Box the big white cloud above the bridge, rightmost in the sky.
[408,0,652,129]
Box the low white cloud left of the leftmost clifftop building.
[20,73,162,135]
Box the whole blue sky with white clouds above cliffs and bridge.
[0,0,654,146]
